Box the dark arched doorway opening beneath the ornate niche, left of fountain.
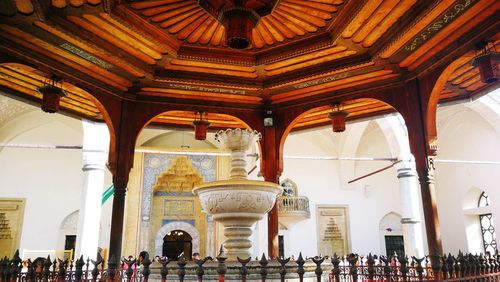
[162,230,193,260]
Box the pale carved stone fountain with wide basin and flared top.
[193,129,281,260]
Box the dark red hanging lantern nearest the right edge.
[471,41,500,83]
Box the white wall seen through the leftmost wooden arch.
[0,109,112,254]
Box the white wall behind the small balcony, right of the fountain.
[282,120,400,256]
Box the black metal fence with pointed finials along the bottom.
[0,252,500,282]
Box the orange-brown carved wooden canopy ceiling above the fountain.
[0,0,500,129]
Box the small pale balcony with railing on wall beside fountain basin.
[277,196,311,228]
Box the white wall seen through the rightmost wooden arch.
[436,105,500,253]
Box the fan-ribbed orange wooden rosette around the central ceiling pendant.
[130,0,344,48]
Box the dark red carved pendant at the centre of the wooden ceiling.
[199,0,278,49]
